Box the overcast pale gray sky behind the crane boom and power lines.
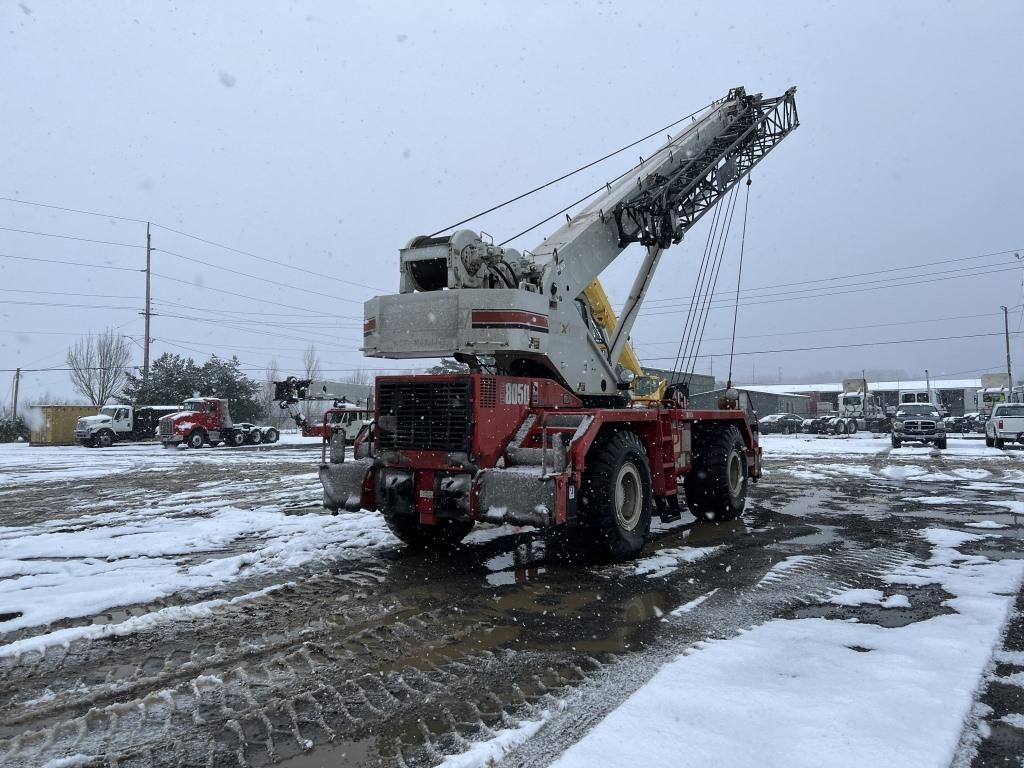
[0,0,1024,405]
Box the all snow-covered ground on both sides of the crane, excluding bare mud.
[0,435,1024,768]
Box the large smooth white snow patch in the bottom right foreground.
[553,528,1024,768]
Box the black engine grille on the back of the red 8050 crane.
[377,379,473,452]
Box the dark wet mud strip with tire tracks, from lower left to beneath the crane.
[0,505,913,768]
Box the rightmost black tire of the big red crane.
[683,426,750,520]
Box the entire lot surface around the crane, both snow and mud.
[0,435,1024,768]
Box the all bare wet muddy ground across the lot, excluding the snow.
[0,438,1024,768]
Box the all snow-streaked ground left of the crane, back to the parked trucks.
[0,434,395,656]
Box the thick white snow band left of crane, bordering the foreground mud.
[0,507,395,656]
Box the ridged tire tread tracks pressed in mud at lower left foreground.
[0,536,614,766]
